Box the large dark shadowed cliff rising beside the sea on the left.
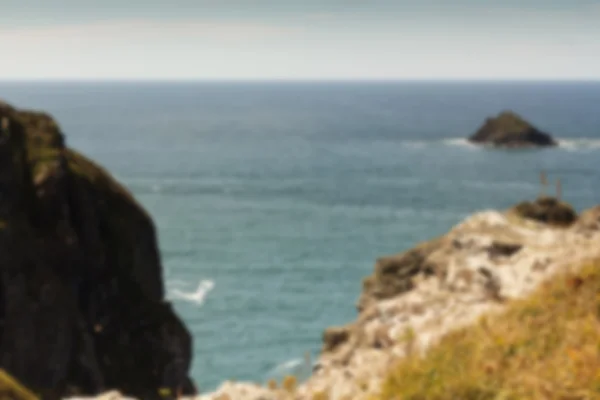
[0,103,195,400]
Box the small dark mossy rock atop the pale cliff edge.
[512,196,577,227]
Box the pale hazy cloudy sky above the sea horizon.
[0,0,600,80]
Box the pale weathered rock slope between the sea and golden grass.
[200,198,600,400]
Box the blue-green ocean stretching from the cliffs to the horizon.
[0,82,600,391]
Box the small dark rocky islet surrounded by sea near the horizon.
[469,111,558,148]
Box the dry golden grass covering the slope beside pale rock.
[374,262,600,400]
